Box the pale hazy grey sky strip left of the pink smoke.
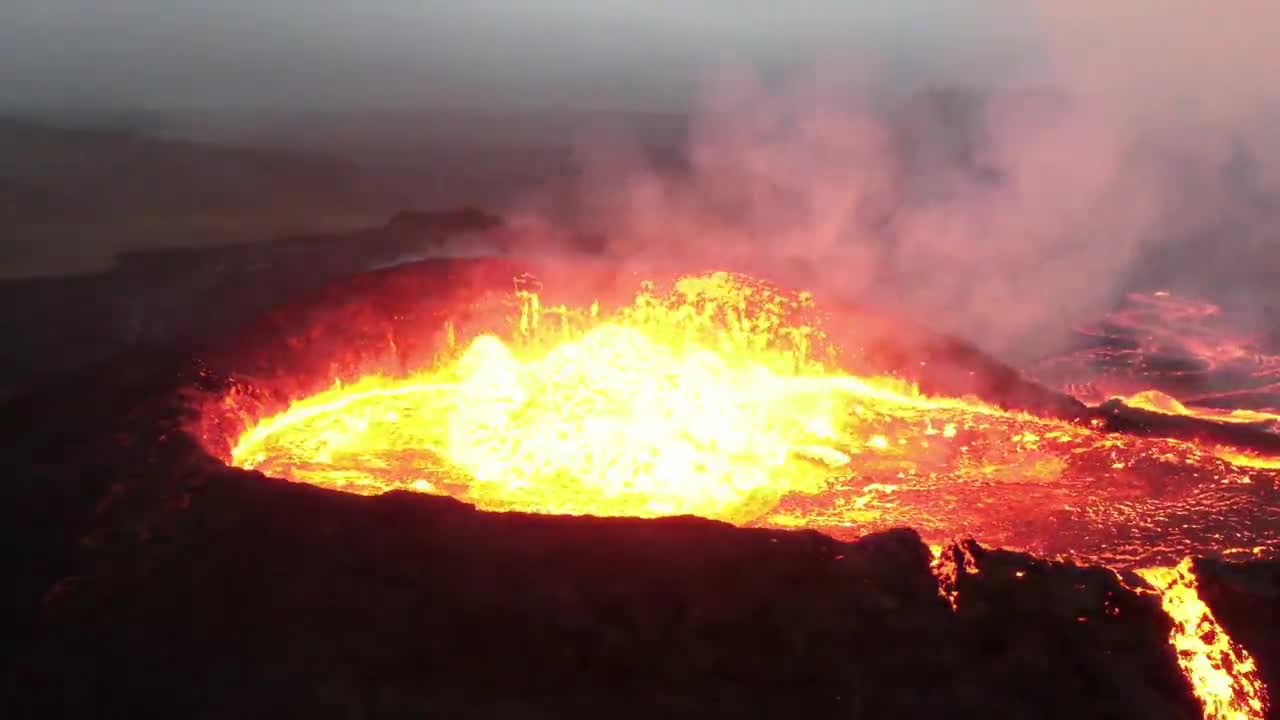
[0,0,1019,108]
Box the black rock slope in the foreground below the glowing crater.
[0,252,1280,720]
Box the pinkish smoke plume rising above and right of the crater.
[509,0,1280,360]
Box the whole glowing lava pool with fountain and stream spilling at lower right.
[229,273,1280,717]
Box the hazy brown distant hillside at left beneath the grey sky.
[0,119,416,277]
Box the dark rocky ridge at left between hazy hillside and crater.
[0,209,502,397]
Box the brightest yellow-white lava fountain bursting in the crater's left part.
[232,273,964,521]
